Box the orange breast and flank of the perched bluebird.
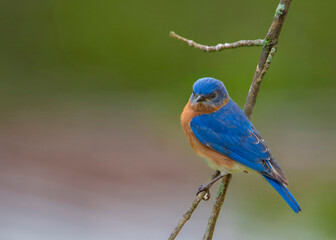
[181,101,240,172]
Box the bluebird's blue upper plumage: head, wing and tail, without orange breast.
[190,78,301,212]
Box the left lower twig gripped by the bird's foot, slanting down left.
[168,171,220,240]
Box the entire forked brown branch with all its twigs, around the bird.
[169,0,291,240]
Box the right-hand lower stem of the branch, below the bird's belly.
[203,174,232,240]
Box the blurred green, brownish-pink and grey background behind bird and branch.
[0,0,336,239]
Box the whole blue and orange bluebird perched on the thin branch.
[181,78,301,213]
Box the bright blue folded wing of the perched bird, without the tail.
[190,99,288,185]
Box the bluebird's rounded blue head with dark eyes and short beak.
[190,77,229,108]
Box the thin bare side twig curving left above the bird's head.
[169,32,266,52]
